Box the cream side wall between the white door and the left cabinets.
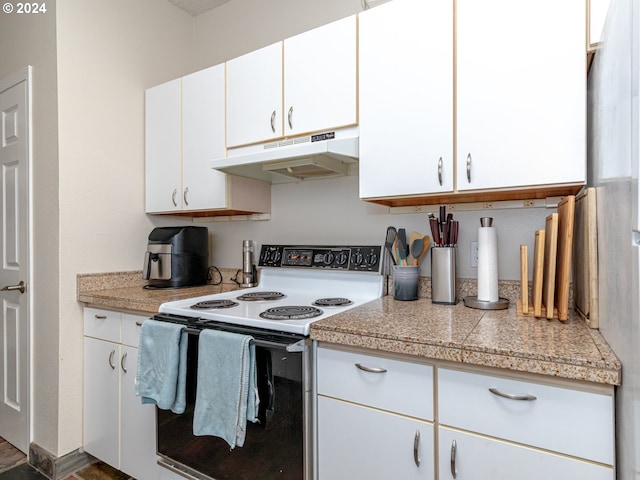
[56,0,193,455]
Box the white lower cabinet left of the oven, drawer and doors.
[84,308,159,480]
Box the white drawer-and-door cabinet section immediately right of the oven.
[317,348,435,480]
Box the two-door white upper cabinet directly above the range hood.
[226,15,357,148]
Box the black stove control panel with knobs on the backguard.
[258,245,382,273]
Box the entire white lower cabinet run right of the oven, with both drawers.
[316,344,615,480]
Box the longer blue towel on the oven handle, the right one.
[193,330,260,449]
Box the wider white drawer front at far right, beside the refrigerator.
[438,369,614,465]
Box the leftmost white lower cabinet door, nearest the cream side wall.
[84,337,120,468]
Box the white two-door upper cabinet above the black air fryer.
[145,65,271,215]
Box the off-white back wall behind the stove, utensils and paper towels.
[189,176,544,280]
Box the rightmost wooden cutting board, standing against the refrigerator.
[573,188,599,328]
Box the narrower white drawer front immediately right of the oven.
[317,347,433,420]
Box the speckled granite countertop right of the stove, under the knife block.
[311,296,621,385]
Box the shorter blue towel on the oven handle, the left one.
[136,320,187,413]
